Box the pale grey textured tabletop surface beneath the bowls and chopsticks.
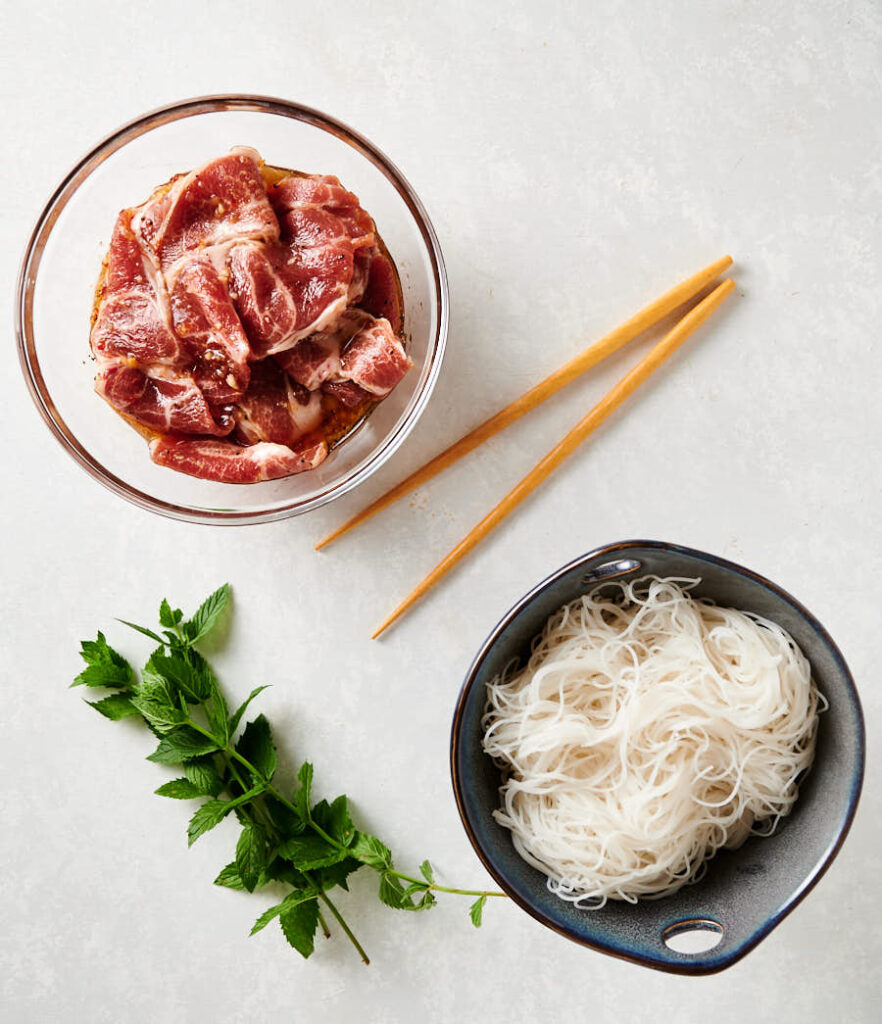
[0,0,882,1024]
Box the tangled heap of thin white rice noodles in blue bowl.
[482,577,826,908]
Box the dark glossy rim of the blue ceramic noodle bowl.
[450,540,866,975]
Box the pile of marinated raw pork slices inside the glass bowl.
[91,147,411,483]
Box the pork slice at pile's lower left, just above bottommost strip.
[95,364,234,437]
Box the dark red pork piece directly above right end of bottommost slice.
[234,359,322,445]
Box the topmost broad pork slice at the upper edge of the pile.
[133,146,279,285]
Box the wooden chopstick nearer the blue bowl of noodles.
[372,279,734,639]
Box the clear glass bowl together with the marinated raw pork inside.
[18,97,447,523]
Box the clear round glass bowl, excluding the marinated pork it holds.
[16,95,448,524]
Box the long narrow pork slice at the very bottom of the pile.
[150,437,328,483]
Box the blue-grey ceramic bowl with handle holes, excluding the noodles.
[451,541,865,974]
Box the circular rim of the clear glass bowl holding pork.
[14,94,450,525]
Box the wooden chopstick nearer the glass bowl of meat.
[316,256,732,551]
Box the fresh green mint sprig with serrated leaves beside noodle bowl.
[72,584,504,964]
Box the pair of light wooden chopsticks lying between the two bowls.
[316,256,734,639]
